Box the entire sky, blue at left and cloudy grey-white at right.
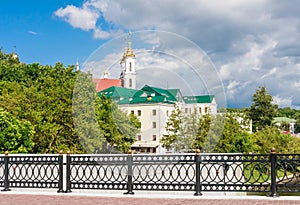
[0,0,300,109]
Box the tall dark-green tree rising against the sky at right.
[249,86,278,131]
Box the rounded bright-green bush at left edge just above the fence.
[0,109,34,153]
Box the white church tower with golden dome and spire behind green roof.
[120,34,136,89]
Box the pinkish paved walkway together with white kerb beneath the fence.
[0,190,300,205]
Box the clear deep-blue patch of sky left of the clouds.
[0,0,102,65]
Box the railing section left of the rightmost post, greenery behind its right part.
[200,154,271,192]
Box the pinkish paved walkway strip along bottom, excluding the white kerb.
[0,193,300,205]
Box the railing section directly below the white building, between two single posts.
[129,154,196,192]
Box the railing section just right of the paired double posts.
[66,154,127,192]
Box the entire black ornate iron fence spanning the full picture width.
[0,149,300,197]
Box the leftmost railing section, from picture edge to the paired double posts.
[0,152,63,192]
